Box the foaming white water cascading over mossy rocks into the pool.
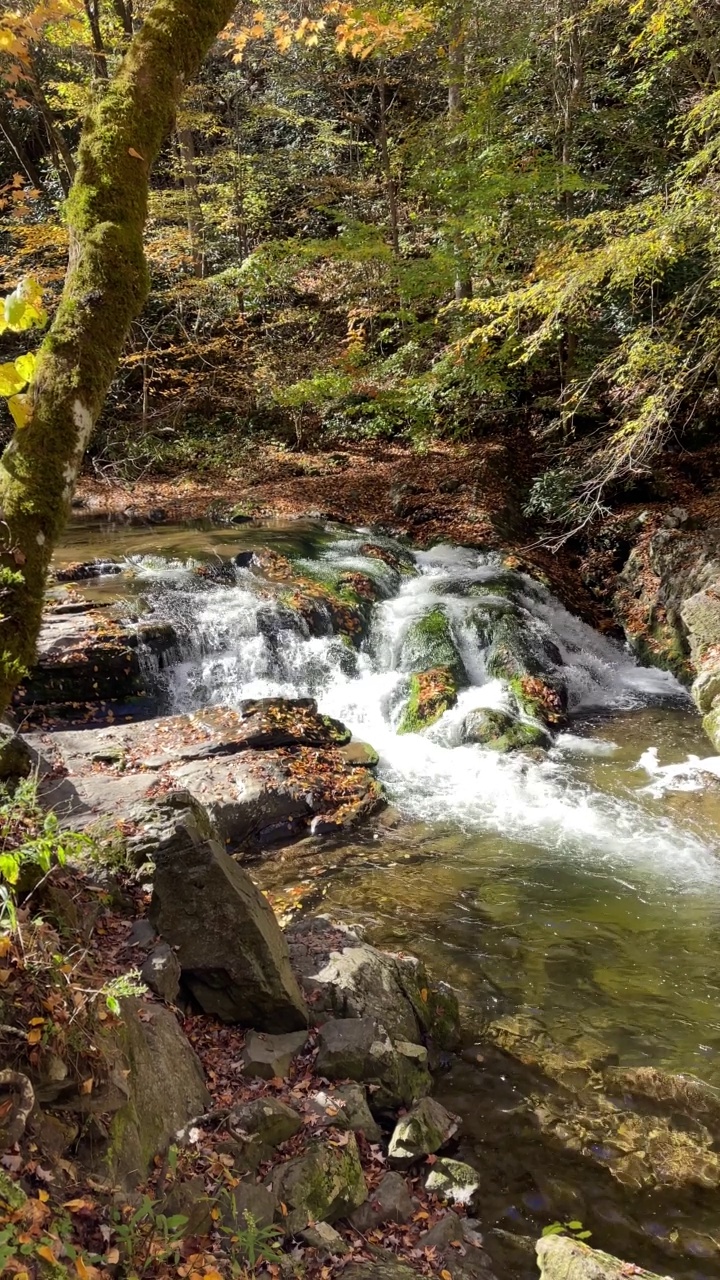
[136,539,719,887]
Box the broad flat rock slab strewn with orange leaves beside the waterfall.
[29,699,384,846]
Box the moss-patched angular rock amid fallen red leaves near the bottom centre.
[265,1134,368,1235]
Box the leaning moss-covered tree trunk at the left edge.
[0,0,236,710]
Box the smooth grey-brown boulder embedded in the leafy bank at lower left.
[102,998,210,1185]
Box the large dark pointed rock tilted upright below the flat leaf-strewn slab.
[150,803,307,1032]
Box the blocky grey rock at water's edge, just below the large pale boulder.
[315,1018,432,1111]
